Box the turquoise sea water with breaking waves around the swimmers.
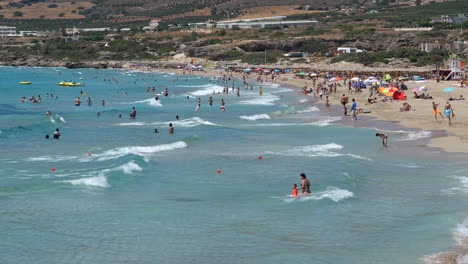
[0,67,468,263]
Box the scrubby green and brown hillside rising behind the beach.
[0,0,468,67]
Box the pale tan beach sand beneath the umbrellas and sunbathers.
[129,65,468,153]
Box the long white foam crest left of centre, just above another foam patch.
[93,141,187,161]
